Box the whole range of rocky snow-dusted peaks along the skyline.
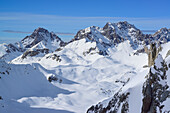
[0,21,170,60]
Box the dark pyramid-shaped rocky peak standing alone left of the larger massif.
[16,28,64,49]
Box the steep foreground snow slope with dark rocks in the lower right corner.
[87,43,170,113]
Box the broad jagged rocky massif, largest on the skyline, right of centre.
[69,21,148,55]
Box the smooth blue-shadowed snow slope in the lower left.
[0,60,74,113]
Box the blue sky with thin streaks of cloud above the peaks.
[0,0,170,43]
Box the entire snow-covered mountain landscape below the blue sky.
[0,22,170,113]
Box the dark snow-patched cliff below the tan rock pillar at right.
[142,55,170,113]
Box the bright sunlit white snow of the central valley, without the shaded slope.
[8,39,148,113]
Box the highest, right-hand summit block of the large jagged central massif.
[102,21,145,47]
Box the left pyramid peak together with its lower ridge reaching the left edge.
[0,28,65,61]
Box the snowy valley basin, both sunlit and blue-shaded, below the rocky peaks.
[0,39,153,113]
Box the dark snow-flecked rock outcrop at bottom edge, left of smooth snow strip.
[87,92,130,113]
